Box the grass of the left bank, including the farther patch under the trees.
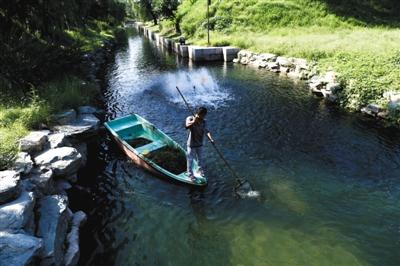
[0,21,120,170]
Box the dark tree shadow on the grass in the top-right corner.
[320,0,400,27]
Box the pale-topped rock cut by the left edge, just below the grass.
[0,170,21,203]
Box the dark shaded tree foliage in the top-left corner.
[0,0,125,89]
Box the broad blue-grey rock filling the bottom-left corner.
[0,232,42,266]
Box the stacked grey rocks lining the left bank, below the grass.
[0,106,100,266]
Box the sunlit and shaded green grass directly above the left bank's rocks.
[0,77,99,170]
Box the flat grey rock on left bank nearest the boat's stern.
[53,114,100,138]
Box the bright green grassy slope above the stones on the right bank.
[147,0,400,122]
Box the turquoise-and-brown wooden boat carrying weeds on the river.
[104,114,207,186]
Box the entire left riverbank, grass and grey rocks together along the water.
[0,19,122,266]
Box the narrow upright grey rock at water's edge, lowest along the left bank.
[64,211,86,266]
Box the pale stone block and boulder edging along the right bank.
[133,22,400,123]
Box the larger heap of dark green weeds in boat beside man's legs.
[145,146,186,175]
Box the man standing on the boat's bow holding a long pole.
[186,107,214,181]
